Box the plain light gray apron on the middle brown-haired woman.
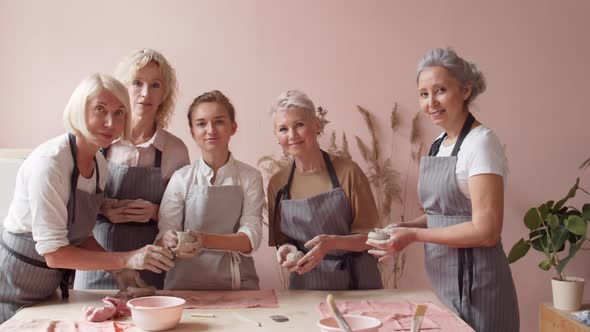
[164,160,259,290]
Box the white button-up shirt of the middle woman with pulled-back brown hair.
[156,155,264,250]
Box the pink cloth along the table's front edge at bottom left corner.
[0,319,133,332]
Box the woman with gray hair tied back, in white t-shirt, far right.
[367,48,519,332]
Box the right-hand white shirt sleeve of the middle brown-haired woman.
[238,171,264,250]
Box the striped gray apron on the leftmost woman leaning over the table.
[0,134,103,322]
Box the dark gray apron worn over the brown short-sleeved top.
[275,151,383,290]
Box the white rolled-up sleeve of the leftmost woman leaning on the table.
[24,160,70,255]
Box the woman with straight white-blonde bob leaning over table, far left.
[0,74,174,322]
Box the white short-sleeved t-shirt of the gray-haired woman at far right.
[436,125,508,198]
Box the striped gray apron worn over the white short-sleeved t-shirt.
[418,113,519,332]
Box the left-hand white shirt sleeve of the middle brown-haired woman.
[155,168,190,241]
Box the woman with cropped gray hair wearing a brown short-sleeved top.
[268,90,382,289]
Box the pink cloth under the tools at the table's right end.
[318,301,473,332]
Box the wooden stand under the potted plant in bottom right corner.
[539,303,590,332]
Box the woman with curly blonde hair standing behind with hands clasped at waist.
[74,49,189,289]
